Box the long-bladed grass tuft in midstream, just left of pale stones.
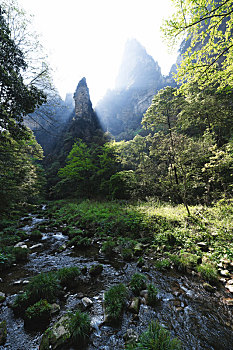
[104,283,127,322]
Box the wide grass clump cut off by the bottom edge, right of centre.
[126,321,182,350]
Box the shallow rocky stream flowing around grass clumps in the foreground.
[0,208,233,350]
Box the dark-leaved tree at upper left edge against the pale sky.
[0,7,46,141]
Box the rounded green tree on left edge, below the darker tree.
[0,129,44,211]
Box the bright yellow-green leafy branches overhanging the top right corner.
[162,0,233,92]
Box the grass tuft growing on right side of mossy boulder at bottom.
[69,310,91,344]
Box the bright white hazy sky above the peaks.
[18,0,176,105]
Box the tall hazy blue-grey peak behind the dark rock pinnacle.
[96,39,175,139]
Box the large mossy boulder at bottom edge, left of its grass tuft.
[39,315,71,350]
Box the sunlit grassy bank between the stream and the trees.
[48,200,233,282]
